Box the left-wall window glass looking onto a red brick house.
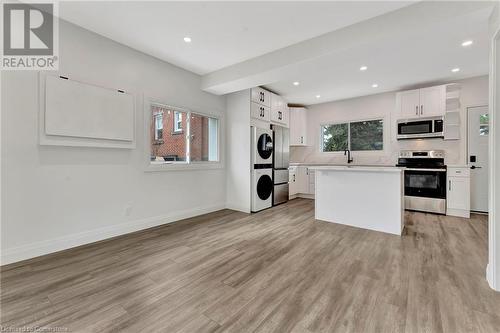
[150,104,219,164]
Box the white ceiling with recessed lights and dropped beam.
[59,1,492,104]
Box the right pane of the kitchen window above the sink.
[351,120,384,150]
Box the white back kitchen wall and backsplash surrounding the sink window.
[290,76,488,165]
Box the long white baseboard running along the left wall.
[0,204,225,265]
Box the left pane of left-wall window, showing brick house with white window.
[151,105,186,162]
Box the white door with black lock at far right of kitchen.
[467,106,489,212]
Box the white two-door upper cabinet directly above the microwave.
[396,85,446,118]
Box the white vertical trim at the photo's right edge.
[486,22,500,291]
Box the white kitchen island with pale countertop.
[310,166,404,235]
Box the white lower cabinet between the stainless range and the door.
[446,167,470,218]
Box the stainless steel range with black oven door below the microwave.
[396,150,446,214]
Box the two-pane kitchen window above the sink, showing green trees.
[321,119,384,152]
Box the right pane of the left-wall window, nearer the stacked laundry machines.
[189,113,219,162]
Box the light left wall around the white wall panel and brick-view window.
[1,22,225,264]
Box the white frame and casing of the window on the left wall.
[143,99,224,172]
